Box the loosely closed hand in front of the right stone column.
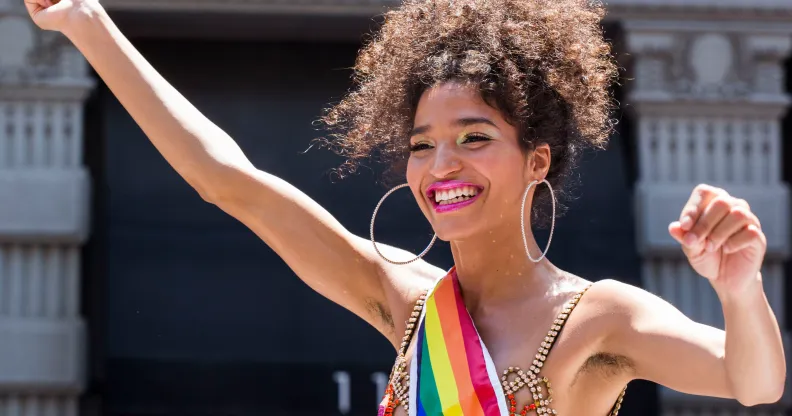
[668,185,767,295]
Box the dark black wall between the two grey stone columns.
[79,40,655,415]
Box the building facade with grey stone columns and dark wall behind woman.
[0,0,792,416]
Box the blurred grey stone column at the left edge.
[0,0,94,416]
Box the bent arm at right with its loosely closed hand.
[600,185,786,406]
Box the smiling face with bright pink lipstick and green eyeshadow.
[407,83,549,241]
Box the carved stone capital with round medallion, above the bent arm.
[627,31,792,102]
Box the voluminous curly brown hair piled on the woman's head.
[320,0,617,222]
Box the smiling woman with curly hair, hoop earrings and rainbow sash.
[25,0,786,415]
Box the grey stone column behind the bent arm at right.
[623,19,792,416]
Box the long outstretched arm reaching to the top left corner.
[25,0,446,345]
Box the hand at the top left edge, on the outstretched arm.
[24,0,103,32]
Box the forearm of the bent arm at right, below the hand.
[718,274,786,405]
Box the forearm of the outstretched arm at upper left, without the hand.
[64,10,249,198]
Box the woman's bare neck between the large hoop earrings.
[451,223,560,311]
